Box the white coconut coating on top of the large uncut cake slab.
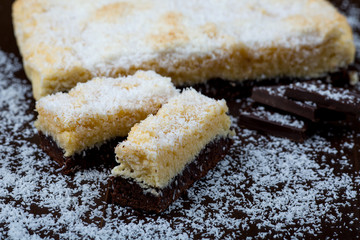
[15,0,336,72]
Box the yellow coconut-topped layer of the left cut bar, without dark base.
[35,71,178,172]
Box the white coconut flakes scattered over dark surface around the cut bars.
[0,48,360,239]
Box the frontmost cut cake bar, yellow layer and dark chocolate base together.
[111,89,231,212]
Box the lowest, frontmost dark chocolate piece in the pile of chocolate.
[239,104,308,142]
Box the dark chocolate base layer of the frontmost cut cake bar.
[110,138,233,213]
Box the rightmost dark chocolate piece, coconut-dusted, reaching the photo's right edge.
[285,81,360,114]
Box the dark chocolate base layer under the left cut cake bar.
[39,132,124,174]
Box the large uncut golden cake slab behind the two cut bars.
[13,0,355,99]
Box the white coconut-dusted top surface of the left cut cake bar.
[37,71,178,125]
